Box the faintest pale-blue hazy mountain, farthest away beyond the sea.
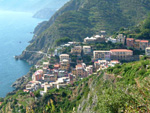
[0,0,68,12]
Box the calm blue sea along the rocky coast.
[0,11,43,97]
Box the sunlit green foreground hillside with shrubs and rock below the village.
[0,60,150,113]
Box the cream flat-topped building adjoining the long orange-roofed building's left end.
[93,51,110,60]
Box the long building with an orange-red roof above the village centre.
[110,49,133,61]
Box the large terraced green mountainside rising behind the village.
[20,0,150,63]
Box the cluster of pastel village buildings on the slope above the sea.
[24,31,150,96]
